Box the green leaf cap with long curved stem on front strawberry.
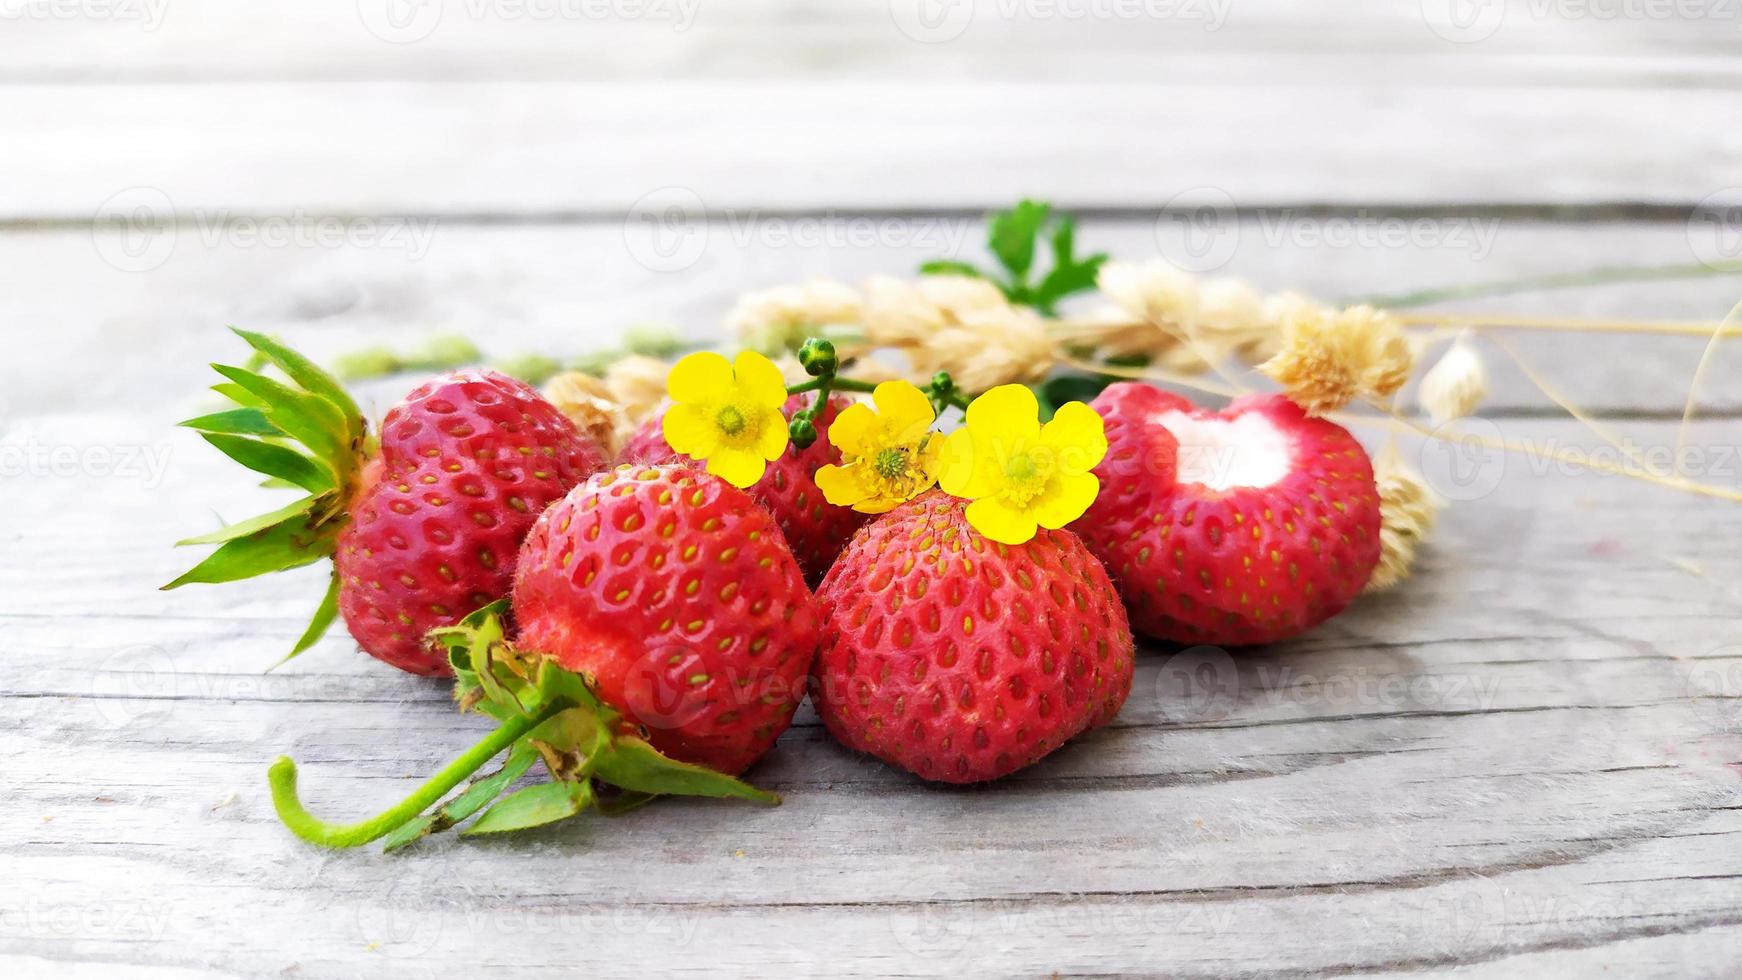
[268,602,780,851]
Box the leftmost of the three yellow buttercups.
[664,350,787,487]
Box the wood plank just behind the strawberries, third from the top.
[0,218,1742,421]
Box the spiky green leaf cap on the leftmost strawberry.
[164,327,373,660]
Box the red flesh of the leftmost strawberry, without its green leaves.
[333,369,604,675]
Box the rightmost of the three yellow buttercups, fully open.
[939,385,1106,545]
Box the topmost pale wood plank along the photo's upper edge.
[0,0,1739,87]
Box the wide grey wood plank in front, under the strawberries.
[0,413,1742,977]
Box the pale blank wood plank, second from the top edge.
[0,80,1735,221]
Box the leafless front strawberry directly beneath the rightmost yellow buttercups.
[810,491,1132,783]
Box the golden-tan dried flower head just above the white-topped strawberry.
[1259,303,1415,414]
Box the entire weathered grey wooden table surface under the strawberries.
[0,0,1742,978]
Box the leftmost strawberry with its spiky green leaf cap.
[165,331,604,675]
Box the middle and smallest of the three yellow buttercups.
[815,381,942,513]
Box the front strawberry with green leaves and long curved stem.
[270,465,819,848]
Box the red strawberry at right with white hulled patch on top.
[1073,383,1380,646]
